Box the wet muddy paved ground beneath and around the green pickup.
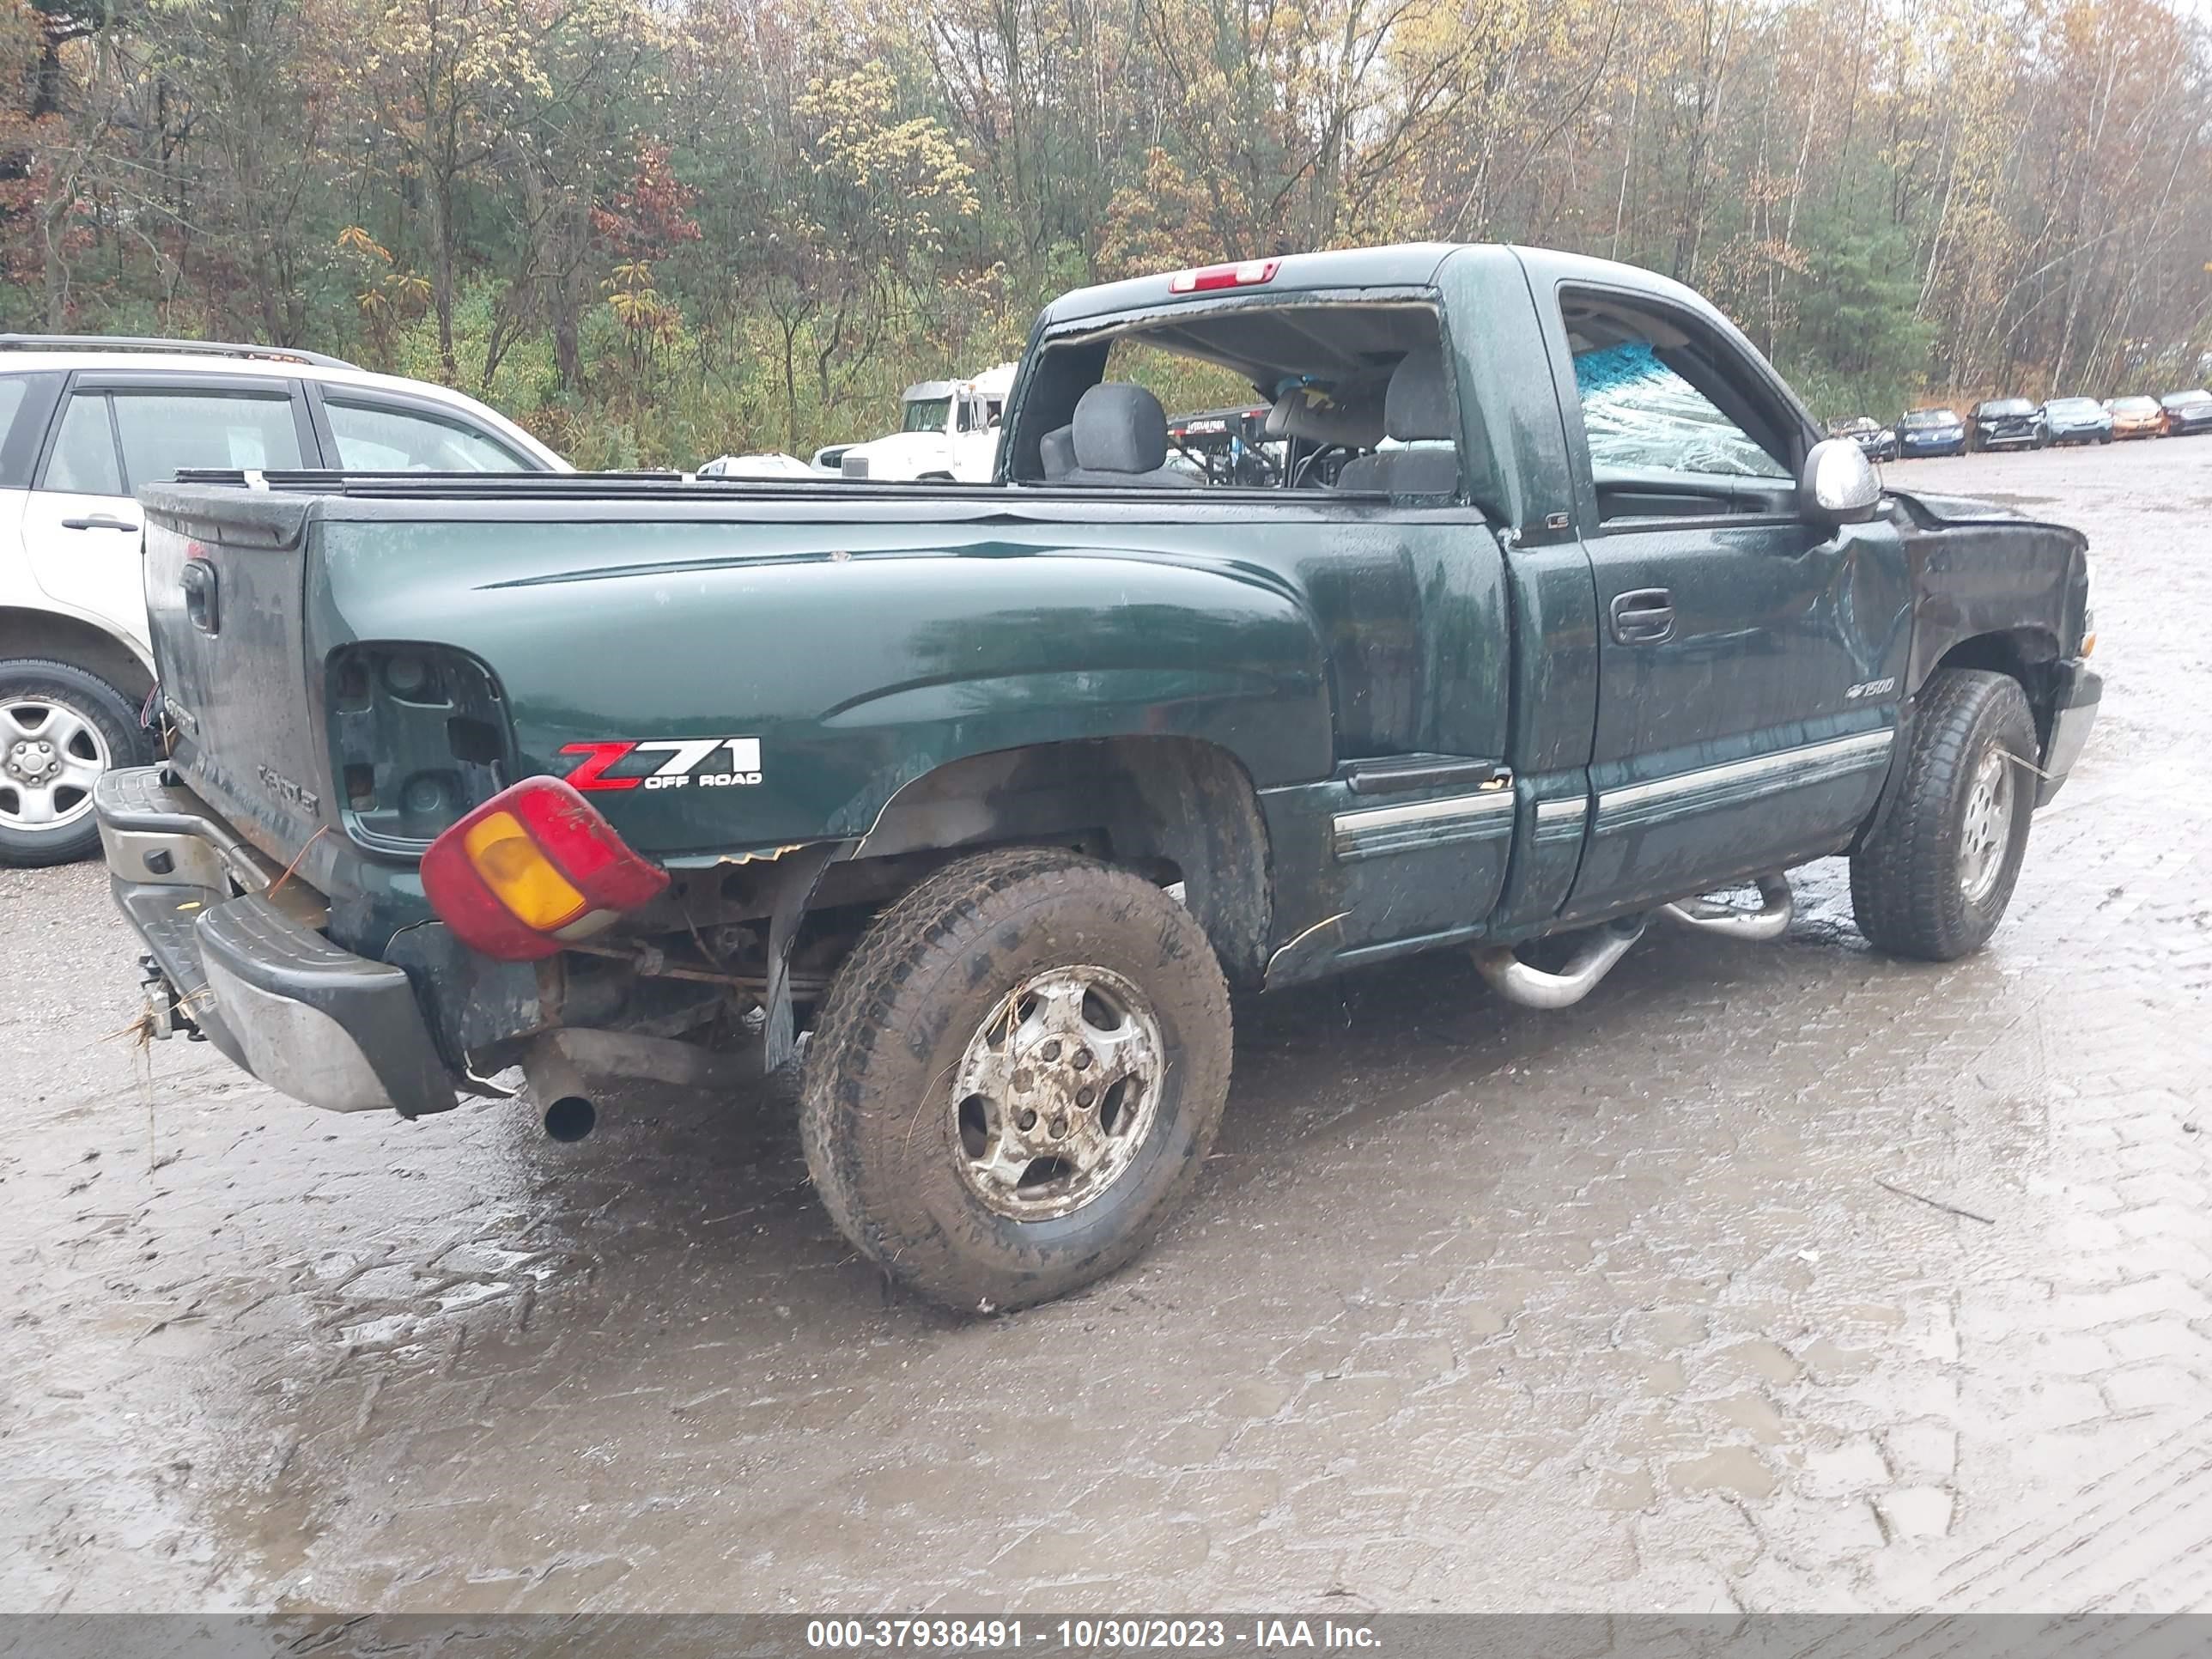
[0,441,2212,1610]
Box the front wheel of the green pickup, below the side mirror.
[1851,668,2037,963]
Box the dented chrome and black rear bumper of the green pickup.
[93,765,453,1117]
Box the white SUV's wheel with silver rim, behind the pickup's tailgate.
[0,657,149,867]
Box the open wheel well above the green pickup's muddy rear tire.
[854,737,1272,984]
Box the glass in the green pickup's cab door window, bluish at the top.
[1575,338,1790,480]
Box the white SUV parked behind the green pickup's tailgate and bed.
[0,334,571,865]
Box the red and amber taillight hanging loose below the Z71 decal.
[422,776,668,963]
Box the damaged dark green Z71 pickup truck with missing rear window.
[97,246,2100,1312]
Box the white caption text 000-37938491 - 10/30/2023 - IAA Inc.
[805,1617,1382,1652]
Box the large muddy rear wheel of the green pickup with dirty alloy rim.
[799,849,1230,1314]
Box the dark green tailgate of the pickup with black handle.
[146,491,331,863]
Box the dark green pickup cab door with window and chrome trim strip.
[1559,288,1911,915]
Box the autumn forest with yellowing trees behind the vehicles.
[0,0,2212,467]
